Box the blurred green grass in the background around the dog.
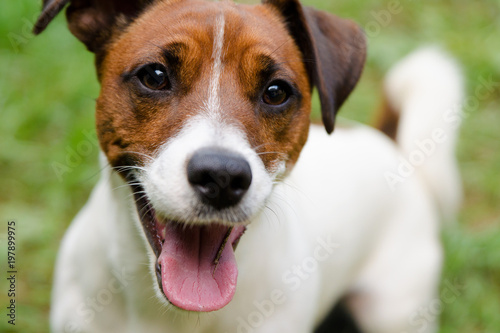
[0,0,500,333]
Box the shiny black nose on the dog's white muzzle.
[187,148,252,209]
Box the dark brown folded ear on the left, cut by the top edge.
[33,0,153,52]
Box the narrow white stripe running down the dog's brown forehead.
[205,12,226,115]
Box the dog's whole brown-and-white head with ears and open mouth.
[35,0,365,311]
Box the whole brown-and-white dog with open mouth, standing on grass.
[34,0,462,333]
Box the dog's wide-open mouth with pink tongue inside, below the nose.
[130,181,245,312]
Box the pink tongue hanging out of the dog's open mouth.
[158,223,245,312]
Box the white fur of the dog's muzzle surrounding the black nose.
[139,115,275,223]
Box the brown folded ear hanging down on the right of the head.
[263,0,366,133]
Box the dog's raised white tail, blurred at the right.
[385,47,464,219]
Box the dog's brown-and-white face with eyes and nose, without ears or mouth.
[97,1,310,225]
